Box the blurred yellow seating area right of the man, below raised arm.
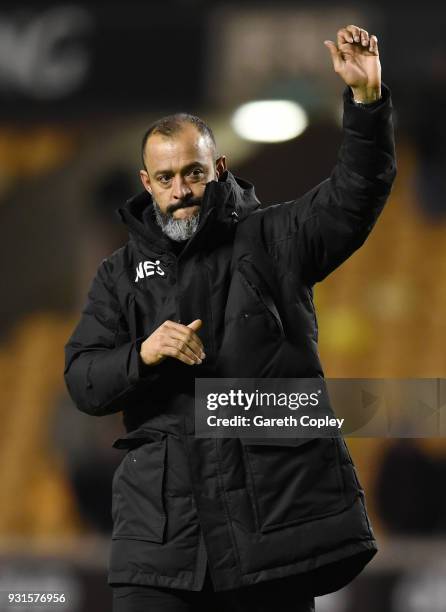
[315,144,446,532]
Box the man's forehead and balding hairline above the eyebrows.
[145,124,213,165]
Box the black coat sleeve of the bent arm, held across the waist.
[64,259,163,416]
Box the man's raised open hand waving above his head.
[324,25,381,103]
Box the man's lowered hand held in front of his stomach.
[141,319,206,365]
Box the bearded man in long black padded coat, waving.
[65,25,396,612]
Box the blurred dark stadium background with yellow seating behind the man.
[0,0,446,612]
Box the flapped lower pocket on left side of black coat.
[112,430,167,542]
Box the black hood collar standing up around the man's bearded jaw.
[116,170,260,251]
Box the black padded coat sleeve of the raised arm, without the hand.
[267,83,396,285]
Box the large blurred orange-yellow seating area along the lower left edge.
[0,313,82,538]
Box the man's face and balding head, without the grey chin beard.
[140,123,226,225]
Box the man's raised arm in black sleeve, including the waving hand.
[265,26,396,285]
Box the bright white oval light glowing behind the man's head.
[232,100,308,142]
